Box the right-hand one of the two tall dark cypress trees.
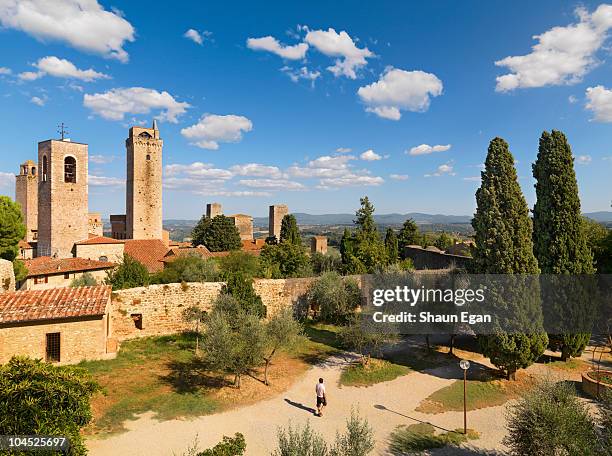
[533,130,595,359]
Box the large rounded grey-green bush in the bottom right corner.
[504,381,609,456]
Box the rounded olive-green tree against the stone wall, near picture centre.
[307,272,361,324]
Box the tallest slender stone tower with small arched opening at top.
[125,121,163,239]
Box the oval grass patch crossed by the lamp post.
[416,380,525,413]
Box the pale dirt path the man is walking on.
[87,358,505,456]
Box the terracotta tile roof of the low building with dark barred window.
[0,285,111,324]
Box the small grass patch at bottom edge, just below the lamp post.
[389,423,479,456]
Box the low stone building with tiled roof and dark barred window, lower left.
[0,286,117,364]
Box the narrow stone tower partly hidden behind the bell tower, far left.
[15,160,38,242]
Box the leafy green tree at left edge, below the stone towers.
[0,196,28,282]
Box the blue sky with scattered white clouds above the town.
[0,0,612,218]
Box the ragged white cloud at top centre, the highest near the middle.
[304,27,374,79]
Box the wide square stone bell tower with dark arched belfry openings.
[38,139,89,258]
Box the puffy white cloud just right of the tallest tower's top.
[181,114,253,150]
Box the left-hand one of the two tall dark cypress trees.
[472,138,548,378]
